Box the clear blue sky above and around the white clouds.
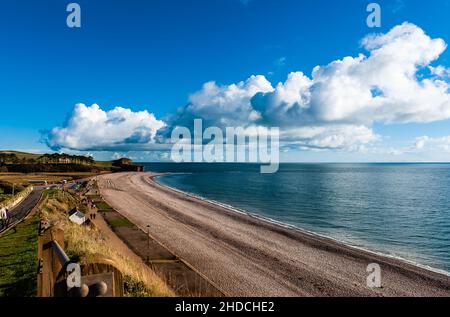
[0,0,450,161]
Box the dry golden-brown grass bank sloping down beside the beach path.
[42,190,174,296]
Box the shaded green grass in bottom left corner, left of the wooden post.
[0,211,39,297]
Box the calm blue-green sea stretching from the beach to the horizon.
[146,163,450,272]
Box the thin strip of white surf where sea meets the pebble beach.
[154,172,450,277]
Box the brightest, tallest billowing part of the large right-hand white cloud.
[253,23,450,126]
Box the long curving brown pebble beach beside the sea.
[98,173,450,296]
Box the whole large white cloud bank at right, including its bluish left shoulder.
[170,23,450,149]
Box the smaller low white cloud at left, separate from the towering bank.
[44,104,165,151]
